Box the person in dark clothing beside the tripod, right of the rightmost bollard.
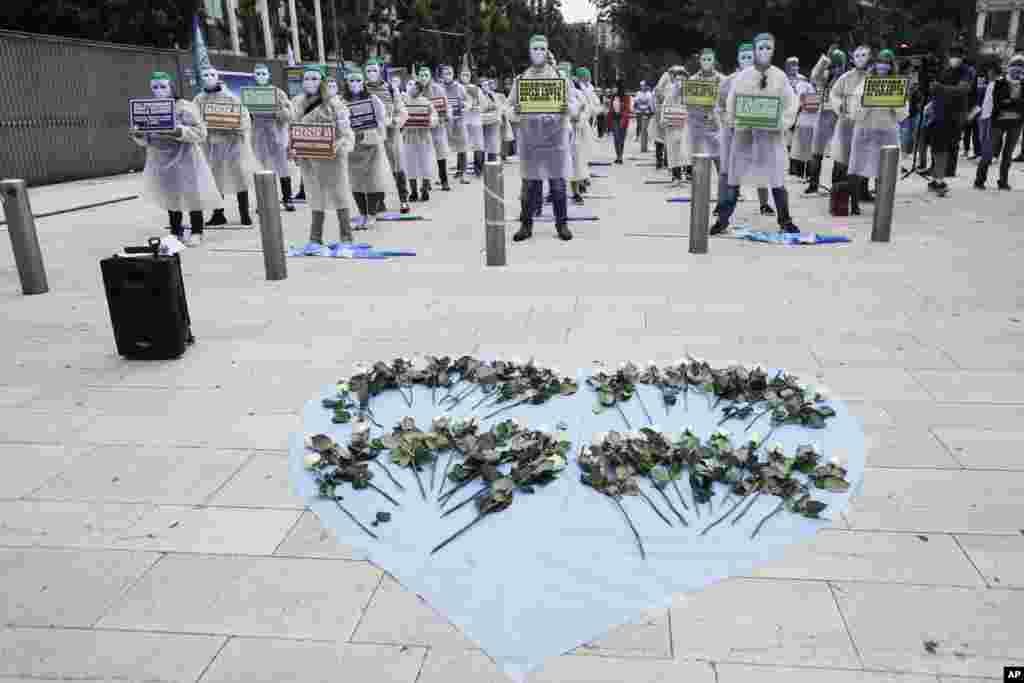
[928,46,976,196]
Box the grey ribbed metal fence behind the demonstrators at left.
[0,31,285,185]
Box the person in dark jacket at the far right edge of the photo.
[974,54,1024,189]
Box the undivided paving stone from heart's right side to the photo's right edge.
[847,469,1024,533]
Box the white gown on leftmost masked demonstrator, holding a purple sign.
[132,99,223,213]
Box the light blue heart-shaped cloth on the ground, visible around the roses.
[289,371,865,682]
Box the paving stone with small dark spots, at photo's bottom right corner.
[836,584,1024,676]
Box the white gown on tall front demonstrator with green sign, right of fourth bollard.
[726,67,799,187]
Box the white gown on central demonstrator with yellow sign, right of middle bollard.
[510,65,580,180]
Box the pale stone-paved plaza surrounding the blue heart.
[0,135,1024,683]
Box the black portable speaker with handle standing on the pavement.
[99,239,196,360]
